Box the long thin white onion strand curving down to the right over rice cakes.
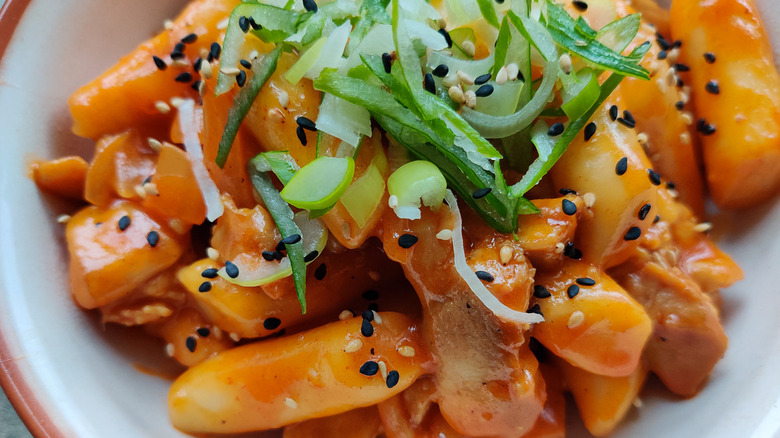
[445,190,544,324]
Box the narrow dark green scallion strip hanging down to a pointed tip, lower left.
[249,167,306,314]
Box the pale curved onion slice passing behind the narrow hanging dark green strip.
[218,211,328,287]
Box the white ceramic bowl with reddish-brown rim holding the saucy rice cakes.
[0,0,780,438]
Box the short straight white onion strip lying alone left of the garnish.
[178,99,224,222]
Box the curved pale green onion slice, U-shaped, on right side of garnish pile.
[461,60,558,138]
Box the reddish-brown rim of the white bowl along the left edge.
[0,0,65,438]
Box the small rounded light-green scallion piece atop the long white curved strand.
[387,160,447,220]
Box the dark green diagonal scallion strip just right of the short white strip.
[215,45,282,167]
